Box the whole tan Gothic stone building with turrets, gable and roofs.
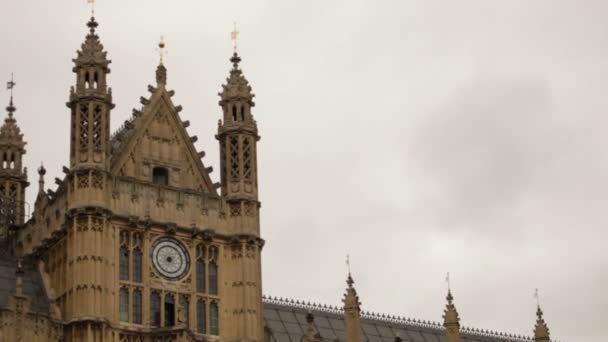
[0,18,549,342]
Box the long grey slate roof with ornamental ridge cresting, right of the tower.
[263,297,532,342]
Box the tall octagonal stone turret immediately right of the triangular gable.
[215,52,264,341]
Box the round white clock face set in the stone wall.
[152,238,190,280]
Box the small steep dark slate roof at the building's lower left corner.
[0,255,50,315]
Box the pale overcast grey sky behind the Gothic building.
[0,0,608,342]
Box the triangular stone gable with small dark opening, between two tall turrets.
[111,86,217,194]
